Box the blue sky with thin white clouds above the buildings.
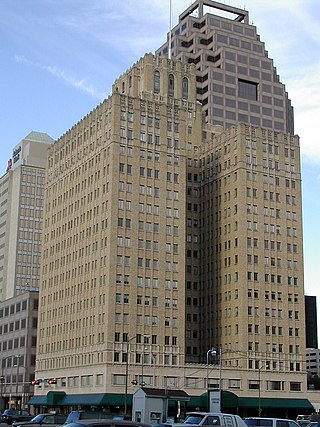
[0,0,320,322]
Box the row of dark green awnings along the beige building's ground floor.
[28,391,315,419]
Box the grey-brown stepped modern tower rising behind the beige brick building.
[156,0,294,134]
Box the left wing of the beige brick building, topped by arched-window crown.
[38,55,202,386]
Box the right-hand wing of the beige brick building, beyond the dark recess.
[196,124,305,372]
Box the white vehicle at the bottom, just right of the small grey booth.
[157,412,247,427]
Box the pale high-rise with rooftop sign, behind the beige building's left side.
[0,132,53,301]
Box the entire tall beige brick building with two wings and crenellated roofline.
[36,49,311,414]
